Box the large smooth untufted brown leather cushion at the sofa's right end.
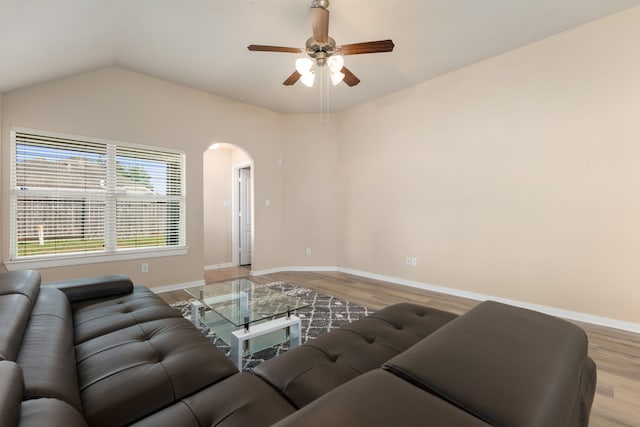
[385,301,595,427]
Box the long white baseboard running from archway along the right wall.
[251,267,640,333]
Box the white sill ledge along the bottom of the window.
[4,247,189,271]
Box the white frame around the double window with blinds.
[4,127,188,270]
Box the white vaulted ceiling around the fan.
[0,0,640,112]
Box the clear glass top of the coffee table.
[185,279,310,326]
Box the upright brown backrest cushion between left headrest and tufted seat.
[17,288,82,411]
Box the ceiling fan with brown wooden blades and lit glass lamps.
[247,0,394,87]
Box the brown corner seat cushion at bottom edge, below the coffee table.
[134,372,295,427]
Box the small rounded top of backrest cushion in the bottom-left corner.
[19,398,87,427]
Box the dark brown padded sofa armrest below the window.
[43,274,133,302]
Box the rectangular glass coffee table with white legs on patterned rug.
[185,279,309,368]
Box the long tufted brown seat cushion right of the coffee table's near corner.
[254,303,457,408]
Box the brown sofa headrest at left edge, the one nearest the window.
[0,270,40,361]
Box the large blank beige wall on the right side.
[338,8,640,322]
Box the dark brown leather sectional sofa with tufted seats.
[0,271,596,427]
